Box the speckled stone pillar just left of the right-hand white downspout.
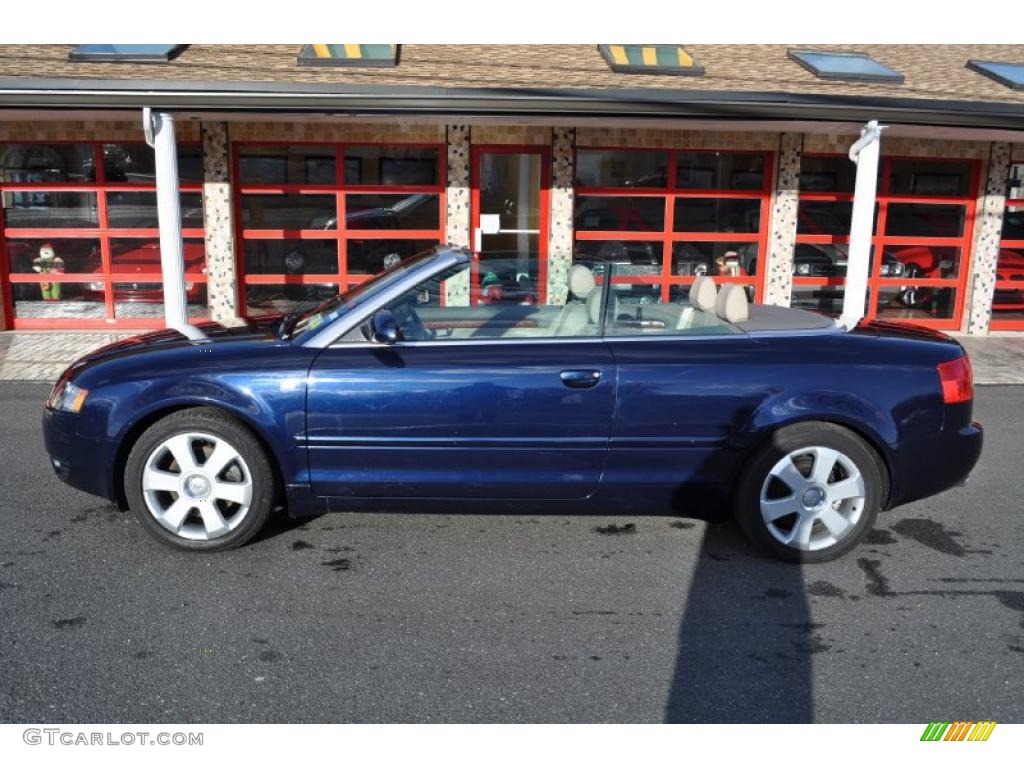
[760,133,804,306]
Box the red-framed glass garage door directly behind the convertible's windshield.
[234,143,445,314]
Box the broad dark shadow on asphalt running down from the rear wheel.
[665,522,815,723]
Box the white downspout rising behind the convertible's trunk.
[839,120,888,331]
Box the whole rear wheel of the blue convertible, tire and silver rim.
[733,422,885,562]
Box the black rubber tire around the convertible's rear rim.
[733,422,888,563]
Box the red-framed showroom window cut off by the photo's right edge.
[992,163,1024,331]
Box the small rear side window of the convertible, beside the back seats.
[604,278,741,336]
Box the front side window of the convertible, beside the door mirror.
[372,259,603,341]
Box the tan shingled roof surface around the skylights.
[0,43,1024,130]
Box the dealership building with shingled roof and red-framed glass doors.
[0,44,1024,336]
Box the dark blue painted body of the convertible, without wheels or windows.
[43,252,981,516]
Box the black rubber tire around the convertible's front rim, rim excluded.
[124,408,278,552]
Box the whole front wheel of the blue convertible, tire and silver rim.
[125,408,275,552]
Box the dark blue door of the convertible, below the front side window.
[307,340,615,499]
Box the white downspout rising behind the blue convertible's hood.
[142,106,207,340]
